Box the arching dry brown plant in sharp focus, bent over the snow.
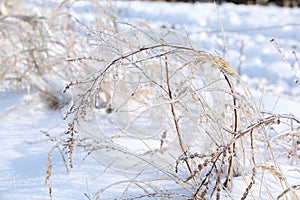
[61,27,300,199]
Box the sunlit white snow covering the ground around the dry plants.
[0,1,300,200]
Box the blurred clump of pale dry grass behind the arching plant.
[0,1,117,108]
